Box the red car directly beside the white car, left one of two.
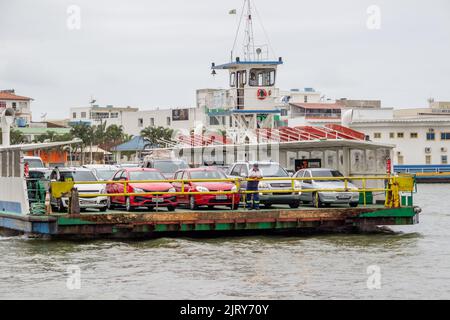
[106,168,177,211]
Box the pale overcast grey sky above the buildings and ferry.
[0,0,450,121]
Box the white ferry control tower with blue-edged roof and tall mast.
[208,0,283,143]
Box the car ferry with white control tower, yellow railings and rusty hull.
[0,0,421,239]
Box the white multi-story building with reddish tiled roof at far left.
[0,89,33,127]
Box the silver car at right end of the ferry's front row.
[294,168,359,208]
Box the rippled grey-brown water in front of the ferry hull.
[0,185,450,299]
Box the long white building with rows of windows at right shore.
[343,106,450,165]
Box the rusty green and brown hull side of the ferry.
[0,205,420,239]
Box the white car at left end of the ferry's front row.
[50,167,108,211]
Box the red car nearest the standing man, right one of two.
[173,167,240,210]
